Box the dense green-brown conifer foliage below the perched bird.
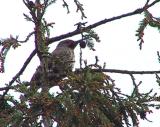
[0,65,159,127]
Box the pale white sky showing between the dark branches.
[0,0,160,127]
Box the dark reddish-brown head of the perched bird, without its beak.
[57,39,78,49]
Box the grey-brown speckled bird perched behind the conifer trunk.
[30,39,81,88]
